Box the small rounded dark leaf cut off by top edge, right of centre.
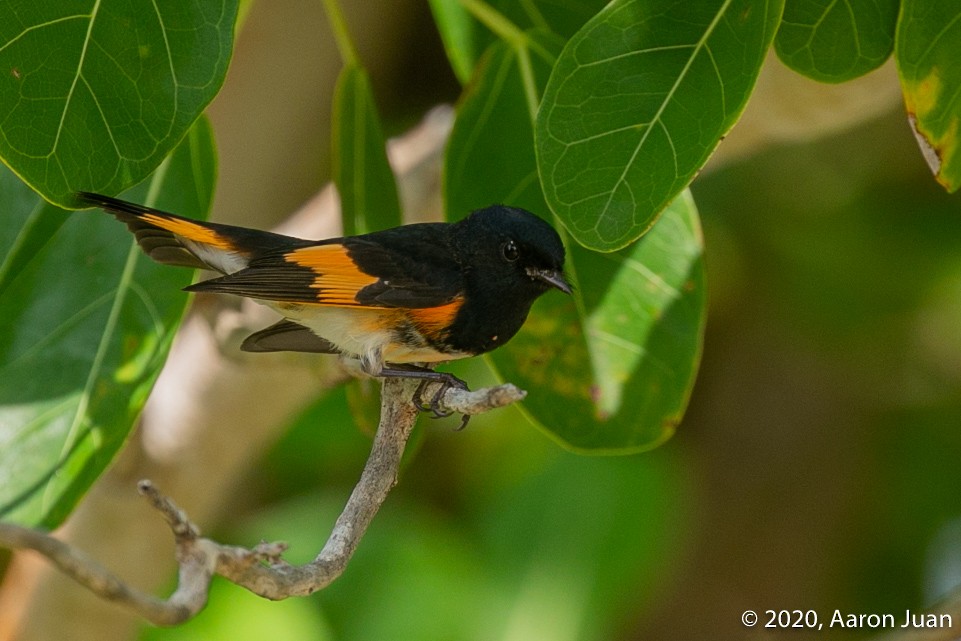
[774,0,900,82]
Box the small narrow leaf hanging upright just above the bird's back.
[333,64,402,236]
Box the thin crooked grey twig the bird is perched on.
[0,379,525,626]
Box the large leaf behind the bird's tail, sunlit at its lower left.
[0,115,215,527]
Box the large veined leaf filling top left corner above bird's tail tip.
[0,0,237,207]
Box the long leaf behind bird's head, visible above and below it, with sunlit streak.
[446,32,705,452]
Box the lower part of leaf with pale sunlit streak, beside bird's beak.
[492,192,706,453]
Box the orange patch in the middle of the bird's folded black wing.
[284,244,380,306]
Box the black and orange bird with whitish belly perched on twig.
[78,193,571,416]
